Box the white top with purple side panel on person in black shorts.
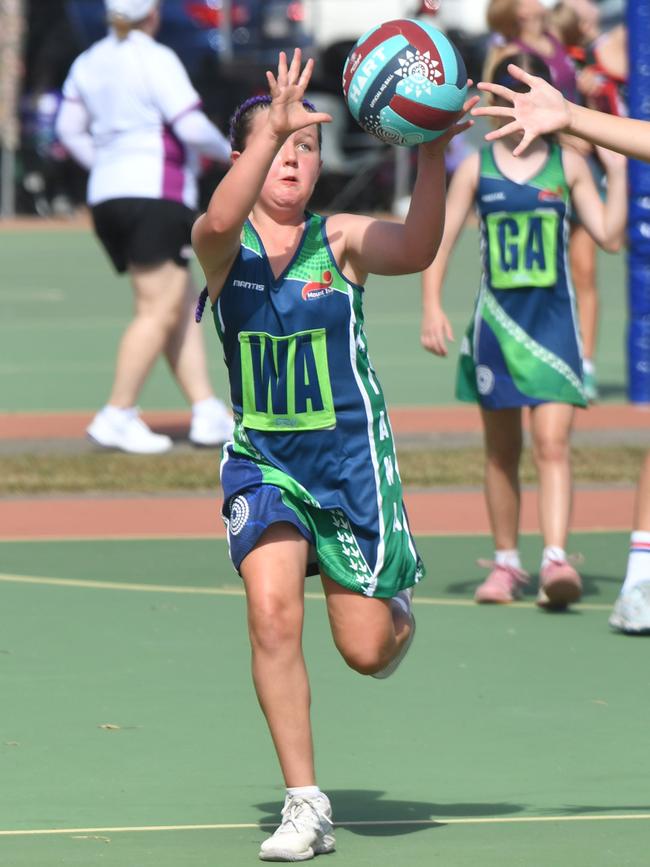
[56,30,230,208]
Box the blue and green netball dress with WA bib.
[213,214,423,597]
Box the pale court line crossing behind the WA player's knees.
[0,573,612,611]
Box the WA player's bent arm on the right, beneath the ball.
[330,90,478,283]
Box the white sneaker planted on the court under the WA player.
[260,794,335,861]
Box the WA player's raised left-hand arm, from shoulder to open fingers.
[192,48,331,292]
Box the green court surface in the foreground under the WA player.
[0,533,650,867]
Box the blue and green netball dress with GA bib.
[456,144,587,409]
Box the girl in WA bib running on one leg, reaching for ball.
[193,51,475,861]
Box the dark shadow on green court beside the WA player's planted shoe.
[255,789,527,837]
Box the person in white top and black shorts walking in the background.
[57,0,232,454]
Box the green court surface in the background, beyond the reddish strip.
[0,228,627,412]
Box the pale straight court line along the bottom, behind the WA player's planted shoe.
[0,813,650,837]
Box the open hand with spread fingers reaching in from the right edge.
[472,63,571,157]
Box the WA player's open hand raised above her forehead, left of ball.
[266,48,332,140]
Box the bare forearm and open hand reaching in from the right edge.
[472,64,650,161]
